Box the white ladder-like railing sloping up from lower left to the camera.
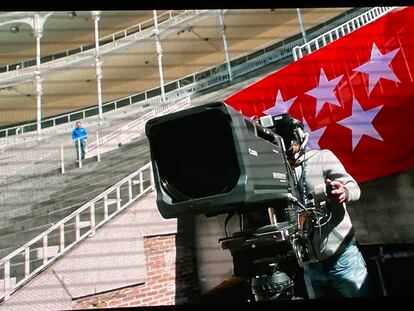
[0,163,154,301]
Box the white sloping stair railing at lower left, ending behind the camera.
[0,163,154,301]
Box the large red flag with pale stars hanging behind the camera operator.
[225,7,414,182]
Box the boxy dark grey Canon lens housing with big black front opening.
[145,102,295,218]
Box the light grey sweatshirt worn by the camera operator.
[295,149,361,261]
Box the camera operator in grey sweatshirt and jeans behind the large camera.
[274,114,372,299]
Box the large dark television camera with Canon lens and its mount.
[145,102,320,301]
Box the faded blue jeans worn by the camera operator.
[303,243,373,299]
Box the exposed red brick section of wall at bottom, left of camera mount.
[73,234,199,309]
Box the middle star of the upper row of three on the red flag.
[305,68,344,115]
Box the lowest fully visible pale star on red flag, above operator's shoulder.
[337,97,384,151]
